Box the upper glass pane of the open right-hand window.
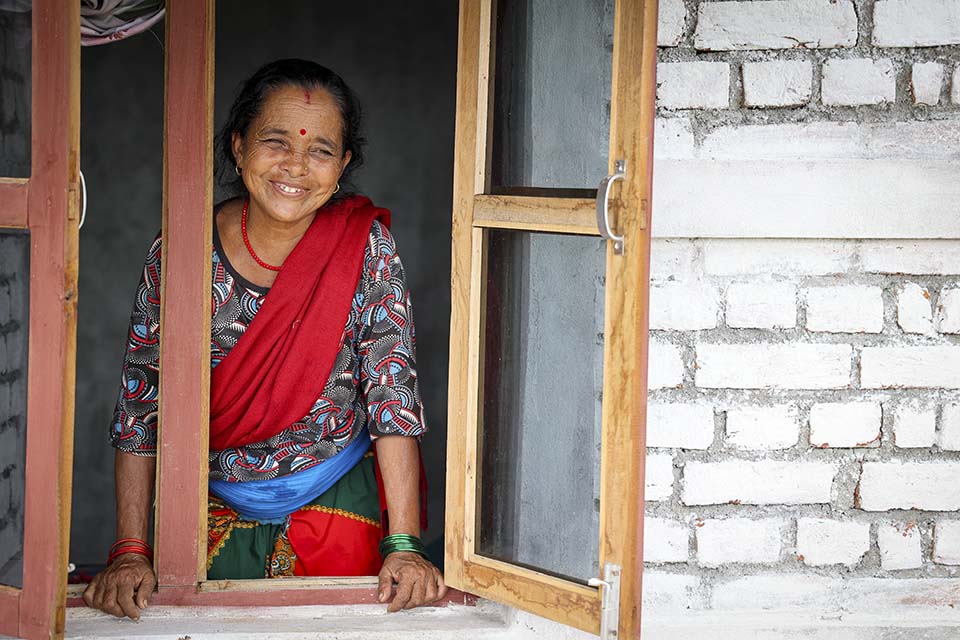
[491,0,614,193]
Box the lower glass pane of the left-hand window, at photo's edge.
[0,230,30,587]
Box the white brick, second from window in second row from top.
[743,60,813,107]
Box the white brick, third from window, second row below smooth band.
[804,285,883,333]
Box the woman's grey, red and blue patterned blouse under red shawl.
[110,215,426,482]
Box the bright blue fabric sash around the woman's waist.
[210,427,370,524]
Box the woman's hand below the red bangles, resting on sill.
[83,553,157,620]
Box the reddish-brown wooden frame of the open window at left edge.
[0,0,80,638]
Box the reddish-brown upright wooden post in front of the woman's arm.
[154,0,214,593]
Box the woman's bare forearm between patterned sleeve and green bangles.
[377,436,420,536]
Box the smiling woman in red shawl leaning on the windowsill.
[84,60,446,619]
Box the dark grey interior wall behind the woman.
[71,0,457,563]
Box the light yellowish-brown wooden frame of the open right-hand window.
[445,0,657,638]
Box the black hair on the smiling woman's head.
[217,58,367,199]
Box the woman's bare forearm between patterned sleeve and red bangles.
[113,450,157,540]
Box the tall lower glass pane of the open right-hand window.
[478,230,606,582]
